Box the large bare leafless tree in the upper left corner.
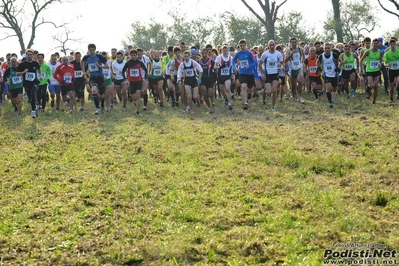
[0,0,70,54]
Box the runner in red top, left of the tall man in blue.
[53,56,76,114]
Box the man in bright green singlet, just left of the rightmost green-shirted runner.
[360,39,382,104]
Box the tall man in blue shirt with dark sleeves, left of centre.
[81,43,109,114]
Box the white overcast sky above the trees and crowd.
[0,0,399,56]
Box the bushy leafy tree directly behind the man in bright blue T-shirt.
[221,13,267,46]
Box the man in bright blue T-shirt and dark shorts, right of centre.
[233,39,257,110]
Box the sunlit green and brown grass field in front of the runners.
[0,91,399,265]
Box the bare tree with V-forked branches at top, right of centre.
[241,0,287,40]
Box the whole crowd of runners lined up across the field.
[0,37,399,118]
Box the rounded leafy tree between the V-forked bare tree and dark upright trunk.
[275,11,320,43]
